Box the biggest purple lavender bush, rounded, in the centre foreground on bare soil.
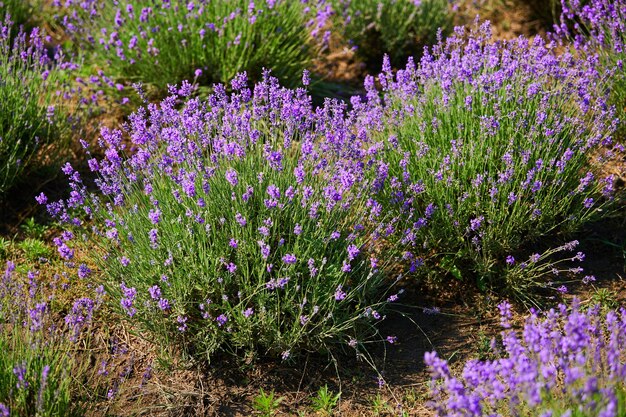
[48,74,393,359]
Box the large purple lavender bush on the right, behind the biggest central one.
[357,23,623,294]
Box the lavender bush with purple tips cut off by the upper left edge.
[0,16,73,195]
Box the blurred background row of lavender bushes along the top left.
[0,0,451,195]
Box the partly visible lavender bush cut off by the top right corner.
[555,0,626,140]
